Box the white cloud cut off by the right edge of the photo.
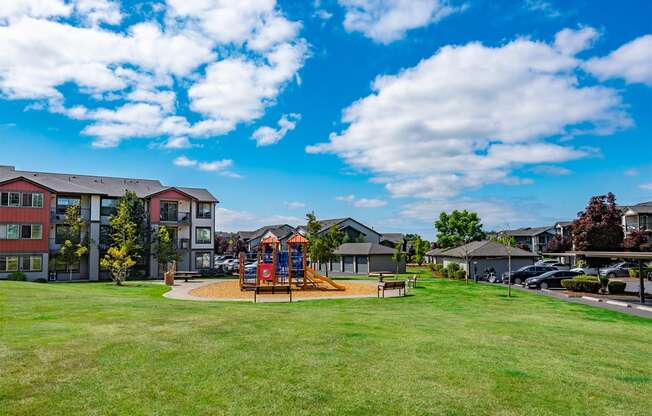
[584,35,652,87]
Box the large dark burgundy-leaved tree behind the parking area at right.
[573,192,623,251]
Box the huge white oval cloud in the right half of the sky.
[306,29,632,205]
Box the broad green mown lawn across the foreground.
[0,268,652,415]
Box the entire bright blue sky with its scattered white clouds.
[0,0,652,238]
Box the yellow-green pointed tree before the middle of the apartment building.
[100,198,141,286]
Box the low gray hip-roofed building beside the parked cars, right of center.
[427,240,539,278]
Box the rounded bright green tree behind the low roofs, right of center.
[435,210,486,248]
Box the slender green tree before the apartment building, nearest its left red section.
[56,205,89,280]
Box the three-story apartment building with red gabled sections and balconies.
[0,166,218,281]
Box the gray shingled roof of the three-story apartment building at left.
[0,166,218,202]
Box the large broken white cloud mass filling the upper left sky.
[0,0,308,147]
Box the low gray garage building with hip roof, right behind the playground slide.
[317,243,405,275]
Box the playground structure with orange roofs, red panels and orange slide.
[239,234,346,290]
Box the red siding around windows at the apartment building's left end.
[0,179,50,253]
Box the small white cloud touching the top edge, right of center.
[338,0,466,44]
